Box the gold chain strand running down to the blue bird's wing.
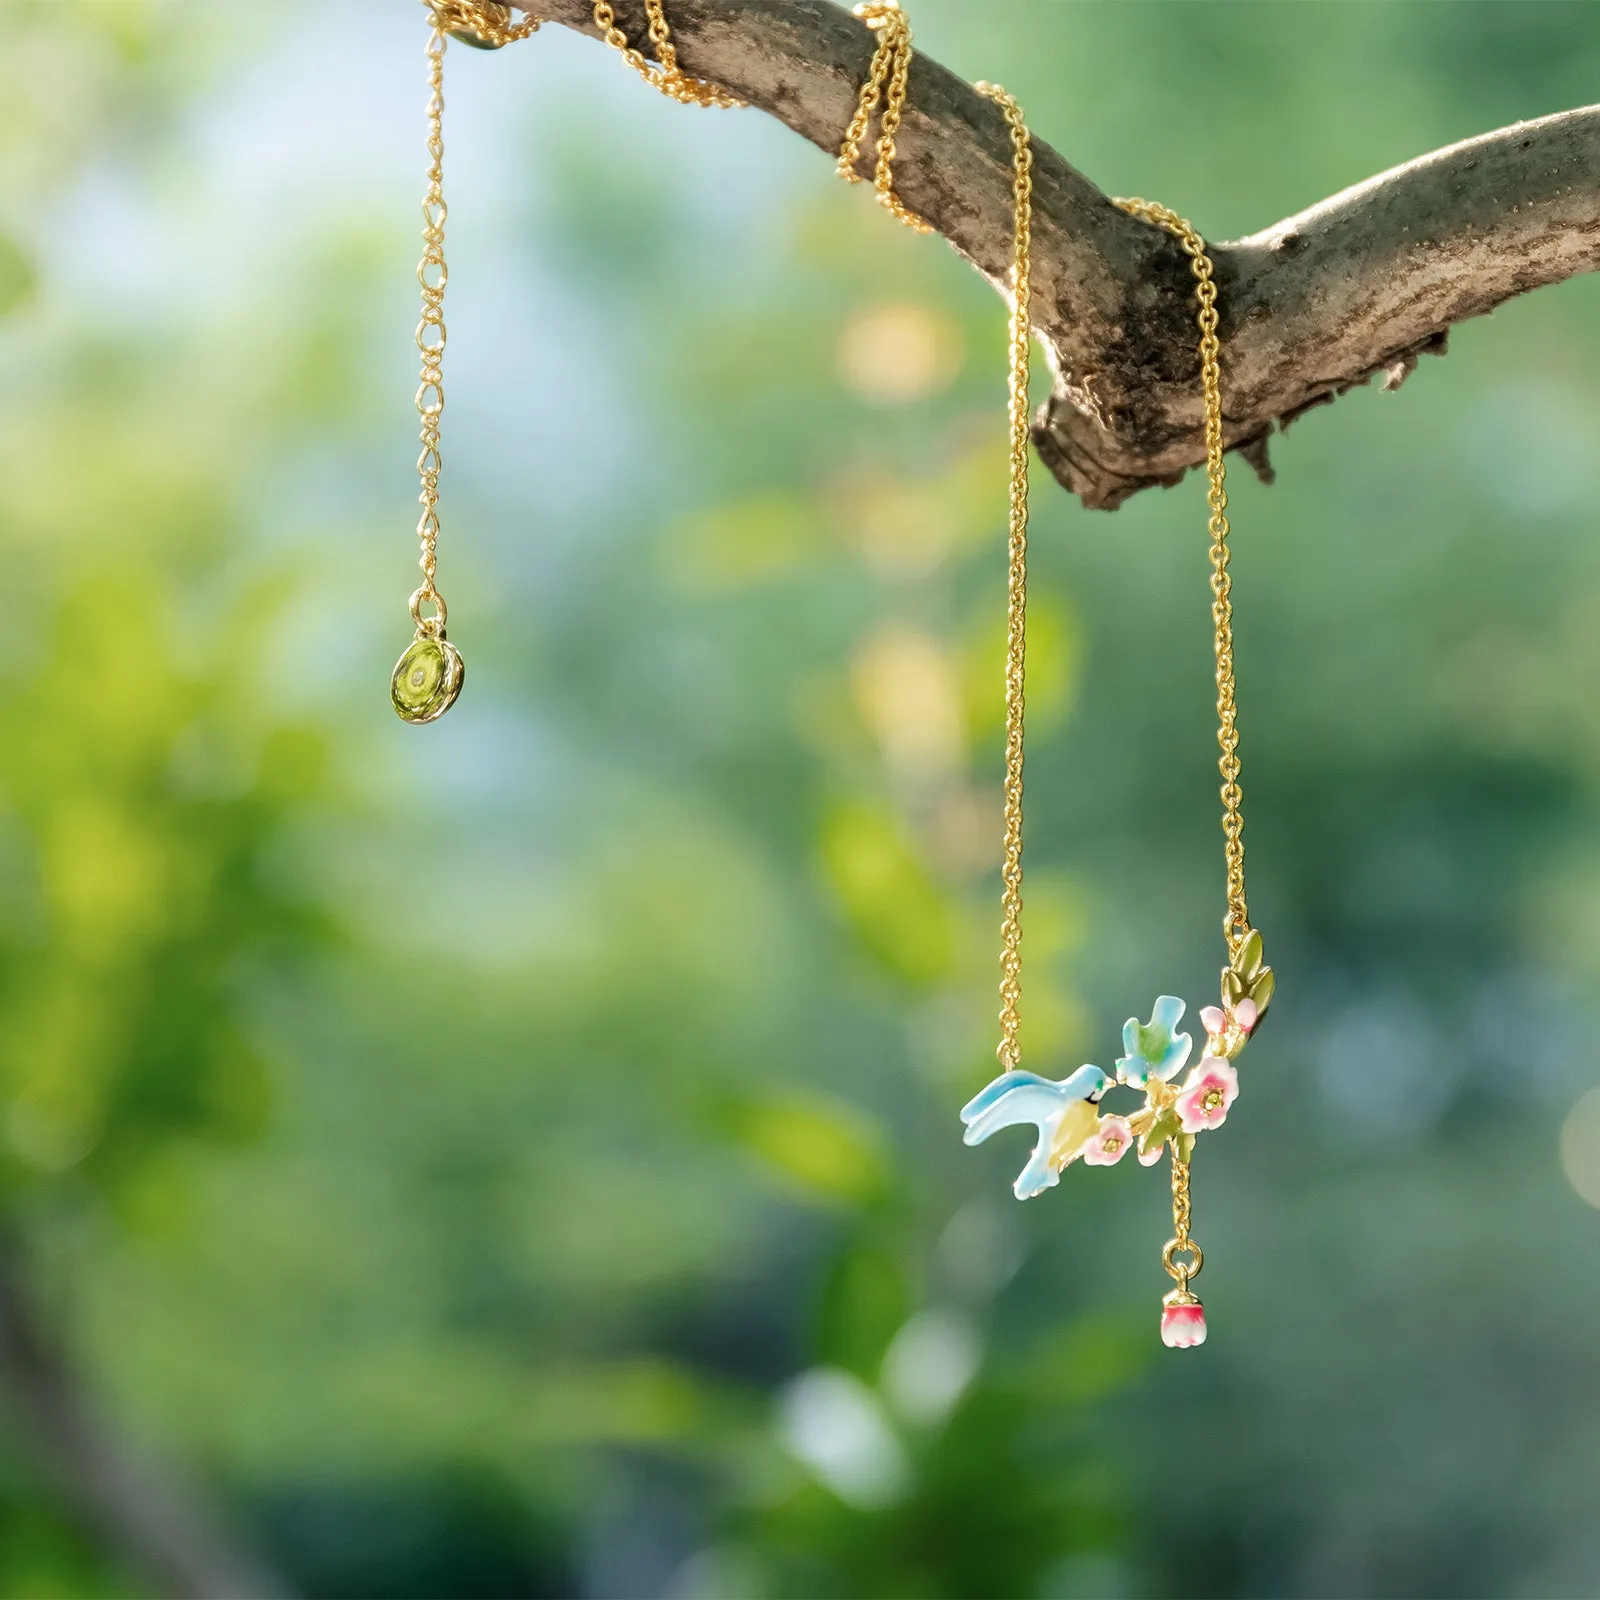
[978,83,1034,1070]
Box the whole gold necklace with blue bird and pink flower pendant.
[390,0,1275,1347]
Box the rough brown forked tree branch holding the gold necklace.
[512,0,1600,509]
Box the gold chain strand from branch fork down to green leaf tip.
[1117,200,1250,957]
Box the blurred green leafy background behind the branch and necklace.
[0,0,1600,1600]
